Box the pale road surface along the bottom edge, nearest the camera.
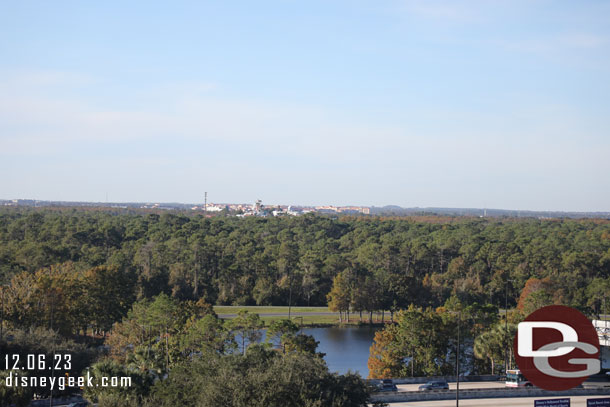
[389,391,610,407]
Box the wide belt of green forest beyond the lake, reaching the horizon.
[0,208,610,311]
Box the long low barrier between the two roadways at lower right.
[372,386,610,403]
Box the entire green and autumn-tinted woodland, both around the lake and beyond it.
[0,208,610,406]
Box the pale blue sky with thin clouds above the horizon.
[0,0,610,211]
